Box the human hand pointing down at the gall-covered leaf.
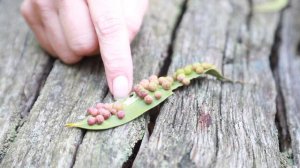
[21,0,148,98]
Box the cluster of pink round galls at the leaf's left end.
[87,102,125,125]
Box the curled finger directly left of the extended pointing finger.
[58,0,99,56]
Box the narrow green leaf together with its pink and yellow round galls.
[66,63,230,130]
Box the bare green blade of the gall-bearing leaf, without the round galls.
[66,65,230,130]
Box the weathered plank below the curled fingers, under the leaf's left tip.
[0,58,107,167]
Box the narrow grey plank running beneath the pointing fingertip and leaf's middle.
[74,0,183,167]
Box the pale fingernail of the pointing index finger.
[113,76,129,99]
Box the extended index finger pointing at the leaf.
[88,0,133,99]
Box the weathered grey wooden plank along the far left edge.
[0,0,52,162]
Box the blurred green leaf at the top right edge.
[253,0,289,13]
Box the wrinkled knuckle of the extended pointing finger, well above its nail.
[96,16,125,36]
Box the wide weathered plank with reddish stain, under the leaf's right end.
[134,0,280,167]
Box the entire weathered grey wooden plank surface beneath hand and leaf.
[0,0,300,168]
